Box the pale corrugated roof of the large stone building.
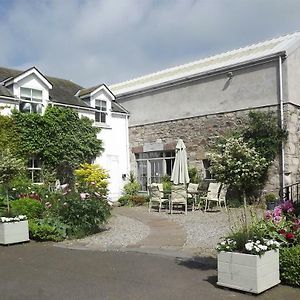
[109,32,300,96]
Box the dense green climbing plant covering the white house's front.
[12,106,103,183]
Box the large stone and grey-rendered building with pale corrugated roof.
[110,32,300,190]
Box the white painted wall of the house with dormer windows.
[0,74,129,201]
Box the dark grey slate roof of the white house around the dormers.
[0,67,128,113]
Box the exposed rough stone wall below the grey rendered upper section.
[129,106,282,192]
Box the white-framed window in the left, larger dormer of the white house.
[19,87,43,114]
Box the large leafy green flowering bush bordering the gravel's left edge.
[58,193,110,238]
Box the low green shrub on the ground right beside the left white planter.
[29,219,67,242]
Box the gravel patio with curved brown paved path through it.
[59,207,248,257]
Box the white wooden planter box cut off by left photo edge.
[0,220,29,245]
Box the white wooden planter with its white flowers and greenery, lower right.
[217,228,280,294]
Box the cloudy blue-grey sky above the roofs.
[0,0,300,87]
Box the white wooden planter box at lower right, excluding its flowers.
[217,250,280,294]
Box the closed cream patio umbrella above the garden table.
[171,139,190,184]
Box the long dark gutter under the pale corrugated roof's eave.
[114,51,286,100]
